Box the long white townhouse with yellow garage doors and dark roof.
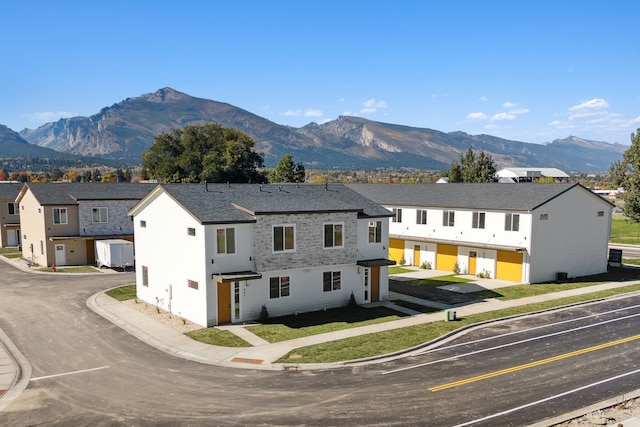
[348,183,613,283]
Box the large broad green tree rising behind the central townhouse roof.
[142,123,266,183]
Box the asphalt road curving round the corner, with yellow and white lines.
[0,262,640,426]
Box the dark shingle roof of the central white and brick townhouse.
[129,184,391,224]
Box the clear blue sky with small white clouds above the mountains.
[0,0,640,145]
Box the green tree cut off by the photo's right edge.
[609,128,640,223]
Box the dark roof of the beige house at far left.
[18,182,153,206]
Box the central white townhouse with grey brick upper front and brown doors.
[129,183,394,327]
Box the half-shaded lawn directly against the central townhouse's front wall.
[248,307,407,342]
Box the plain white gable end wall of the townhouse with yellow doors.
[530,187,611,283]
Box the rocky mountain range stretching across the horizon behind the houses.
[0,88,628,172]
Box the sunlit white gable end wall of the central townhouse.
[134,194,207,326]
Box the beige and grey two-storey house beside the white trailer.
[15,183,153,266]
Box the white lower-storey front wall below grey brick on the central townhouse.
[241,265,362,320]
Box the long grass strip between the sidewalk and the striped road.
[276,284,640,363]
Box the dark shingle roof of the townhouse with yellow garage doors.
[347,183,611,211]
